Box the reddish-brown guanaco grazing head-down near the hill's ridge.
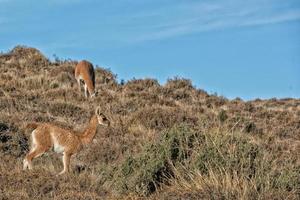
[75,60,96,98]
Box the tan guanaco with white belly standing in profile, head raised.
[23,107,110,174]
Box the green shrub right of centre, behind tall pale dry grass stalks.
[195,134,262,178]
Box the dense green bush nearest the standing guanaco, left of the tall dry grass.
[116,126,195,196]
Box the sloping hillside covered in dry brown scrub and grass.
[0,46,300,200]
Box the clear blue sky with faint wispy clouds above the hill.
[0,0,300,100]
